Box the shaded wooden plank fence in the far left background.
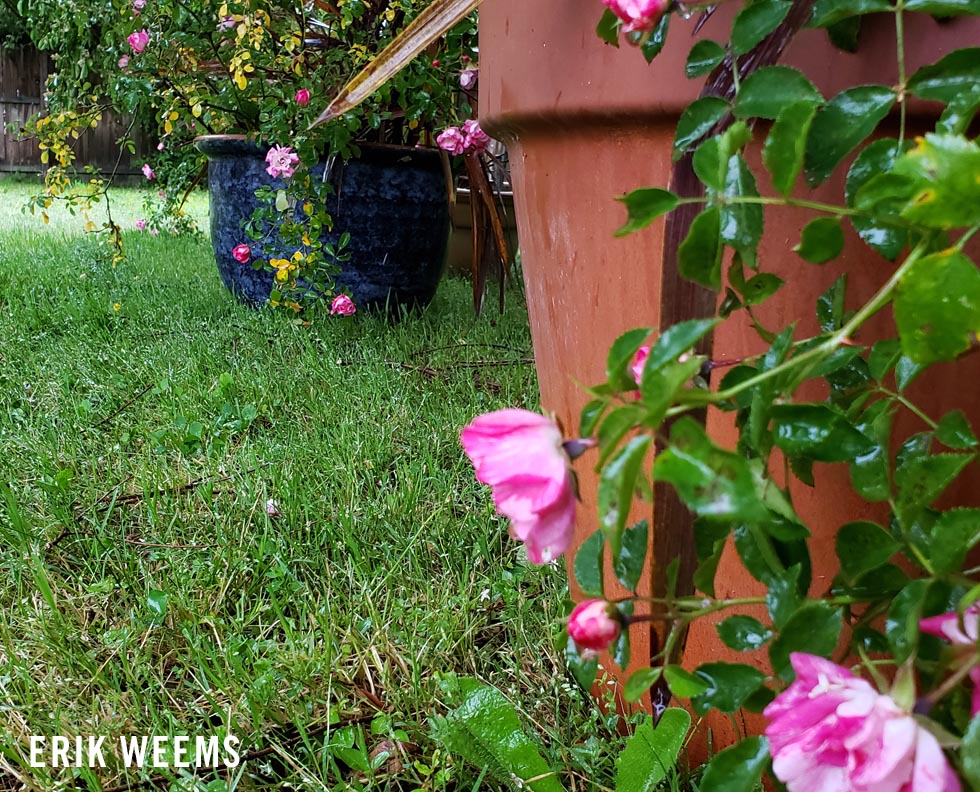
[0,47,153,176]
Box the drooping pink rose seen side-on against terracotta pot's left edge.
[460,410,576,564]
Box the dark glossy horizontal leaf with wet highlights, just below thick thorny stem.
[772,404,872,462]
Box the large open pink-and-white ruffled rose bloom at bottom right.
[764,652,961,792]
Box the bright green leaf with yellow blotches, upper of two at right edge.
[893,134,980,230]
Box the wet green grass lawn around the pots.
[0,182,615,791]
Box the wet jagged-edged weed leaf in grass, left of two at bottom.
[445,685,563,792]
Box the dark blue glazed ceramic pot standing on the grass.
[195,135,450,315]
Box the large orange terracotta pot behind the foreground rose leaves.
[480,0,980,749]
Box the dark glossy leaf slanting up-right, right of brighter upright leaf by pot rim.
[806,85,895,187]
